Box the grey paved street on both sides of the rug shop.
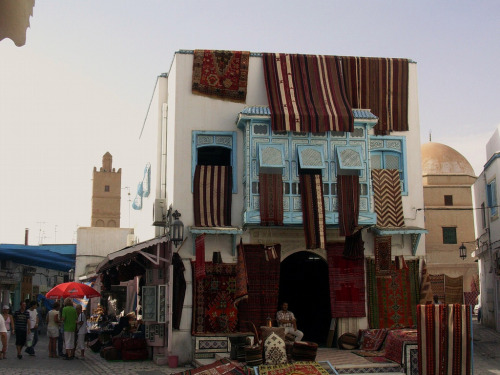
[0,318,500,375]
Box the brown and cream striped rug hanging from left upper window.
[193,165,232,227]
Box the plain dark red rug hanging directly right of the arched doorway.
[326,243,366,318]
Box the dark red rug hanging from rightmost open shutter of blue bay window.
[337,175,359,237]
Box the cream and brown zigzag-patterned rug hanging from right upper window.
[372,169,405,227]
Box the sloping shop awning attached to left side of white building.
[96,236,171,273]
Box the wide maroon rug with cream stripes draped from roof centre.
[262,53,354,133]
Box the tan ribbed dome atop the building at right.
[421,142,475,176]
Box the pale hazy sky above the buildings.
[0,0,500,245]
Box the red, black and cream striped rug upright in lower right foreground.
[417,304,472,375]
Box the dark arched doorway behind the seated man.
[278,251,331,345]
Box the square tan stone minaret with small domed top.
[90,152,122,228]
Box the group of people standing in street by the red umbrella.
[0,298,87,359]
